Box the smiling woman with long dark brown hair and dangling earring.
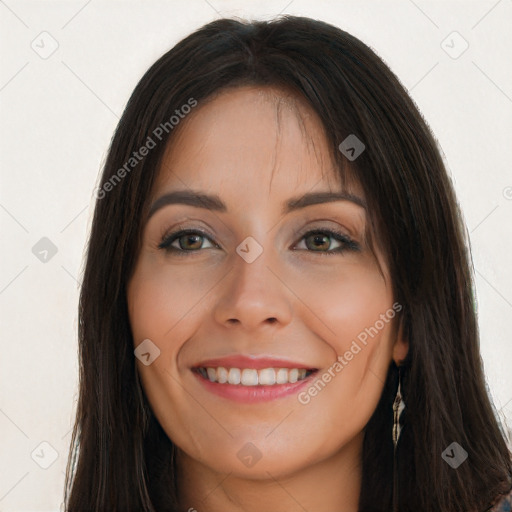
[66,17,512,512]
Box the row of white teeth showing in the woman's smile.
[199,366,311,386]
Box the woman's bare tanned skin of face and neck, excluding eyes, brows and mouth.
[127,87,408,512]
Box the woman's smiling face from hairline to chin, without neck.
[128,87,407,478]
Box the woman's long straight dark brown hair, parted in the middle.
[65,16,512,512]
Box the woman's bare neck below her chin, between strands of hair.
[177,433,364,512]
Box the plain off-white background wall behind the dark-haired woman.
[0,0,512,512]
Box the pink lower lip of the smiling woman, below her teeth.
[192,372,317,404]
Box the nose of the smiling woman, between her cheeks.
[214,244,293,331]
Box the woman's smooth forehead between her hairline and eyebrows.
[155,86,362,197]
